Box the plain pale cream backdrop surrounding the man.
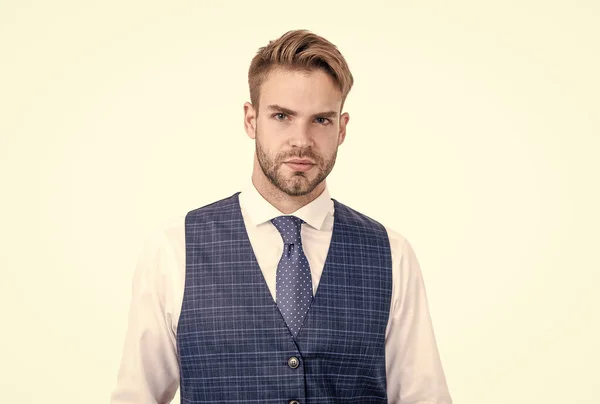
[0,0,600,404]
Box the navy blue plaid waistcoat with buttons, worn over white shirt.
[177,193,392,404]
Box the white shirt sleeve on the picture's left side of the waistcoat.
[110,226,179,404]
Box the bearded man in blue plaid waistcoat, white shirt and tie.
[112,30,452,404]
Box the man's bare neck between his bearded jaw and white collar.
[252,167,325,215]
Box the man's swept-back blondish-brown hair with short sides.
[248,30,354,112]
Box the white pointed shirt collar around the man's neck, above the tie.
[239,180,334,230]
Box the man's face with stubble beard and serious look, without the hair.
[245,69,348,196]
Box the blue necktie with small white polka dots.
[271,216,312,338]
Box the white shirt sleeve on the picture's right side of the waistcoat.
[386,238,452,404]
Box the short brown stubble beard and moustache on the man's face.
[256,133,337,196]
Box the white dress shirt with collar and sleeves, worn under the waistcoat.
[111,182,452,404]
